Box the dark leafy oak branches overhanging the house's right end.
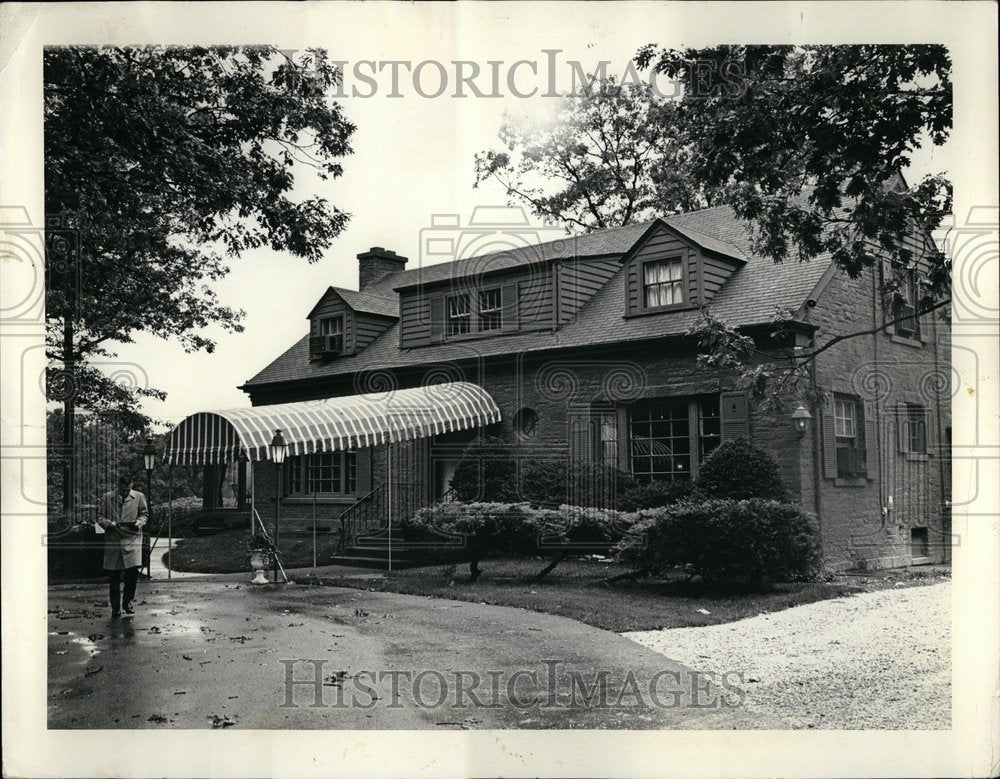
[635,44,952,300]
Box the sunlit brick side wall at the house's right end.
[809,271,951,569]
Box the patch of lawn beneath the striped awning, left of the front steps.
[163,529,337,573]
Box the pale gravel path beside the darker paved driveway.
[623,582,951,730]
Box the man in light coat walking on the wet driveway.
[97,475,149,619]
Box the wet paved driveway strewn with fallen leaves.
[48,580,781,729]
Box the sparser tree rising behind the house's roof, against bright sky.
[475,77,719,232]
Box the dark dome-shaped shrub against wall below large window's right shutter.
[695,438,785,501]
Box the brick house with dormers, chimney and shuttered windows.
[241,207,951,569]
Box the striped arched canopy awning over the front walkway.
[166,382,508,465]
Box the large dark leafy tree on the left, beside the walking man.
[44,46,354,507]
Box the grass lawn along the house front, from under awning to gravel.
[165,530,940,633]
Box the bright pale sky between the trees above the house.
[95,14,960,432]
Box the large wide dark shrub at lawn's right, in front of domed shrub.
[616,499,820,586]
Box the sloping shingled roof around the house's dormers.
[243,206,830,389]
